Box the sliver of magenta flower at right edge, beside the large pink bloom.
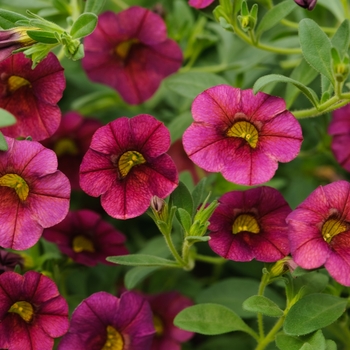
[328,104,350,171]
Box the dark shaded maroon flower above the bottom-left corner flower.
[43,210,128,266]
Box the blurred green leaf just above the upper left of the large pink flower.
[165,72,228,99]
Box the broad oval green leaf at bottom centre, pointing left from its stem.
[174,304,250,335]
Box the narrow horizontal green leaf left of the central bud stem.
[106,254,179,267]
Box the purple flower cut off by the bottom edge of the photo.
[58,292,155,350]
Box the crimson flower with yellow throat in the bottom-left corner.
[0,271,69,350]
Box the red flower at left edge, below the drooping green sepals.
[0,53,66,141]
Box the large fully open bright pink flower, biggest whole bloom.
[183,85,302,185]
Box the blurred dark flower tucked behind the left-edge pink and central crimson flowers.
[42,112,102,190]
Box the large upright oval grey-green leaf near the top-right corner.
[299,18,334,82]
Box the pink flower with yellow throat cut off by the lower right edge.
[287,181,350,286]
